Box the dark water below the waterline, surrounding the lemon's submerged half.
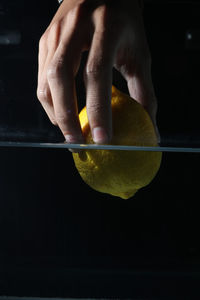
[0,149,200,297]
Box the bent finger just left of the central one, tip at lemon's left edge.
[47,43,83,143]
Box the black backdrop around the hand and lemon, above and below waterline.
[0,1,200,299]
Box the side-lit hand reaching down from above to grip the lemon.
[37,0,157,143]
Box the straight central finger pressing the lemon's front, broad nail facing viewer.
[85,8,116,143]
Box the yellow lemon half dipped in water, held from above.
[73,87,162,199]
